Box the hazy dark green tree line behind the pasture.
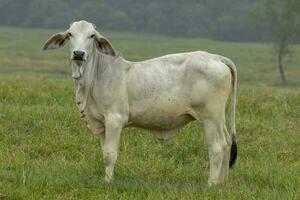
[0,0,264,41]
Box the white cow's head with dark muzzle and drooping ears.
[43,21,116,64]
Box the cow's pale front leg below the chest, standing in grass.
[101,117,123,183]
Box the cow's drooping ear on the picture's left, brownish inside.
[43,32,69,50]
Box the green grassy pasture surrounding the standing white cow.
[0,28,300,200]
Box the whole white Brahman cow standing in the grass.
[43,21,237,185]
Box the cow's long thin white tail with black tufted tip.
[222,57,237,168]
